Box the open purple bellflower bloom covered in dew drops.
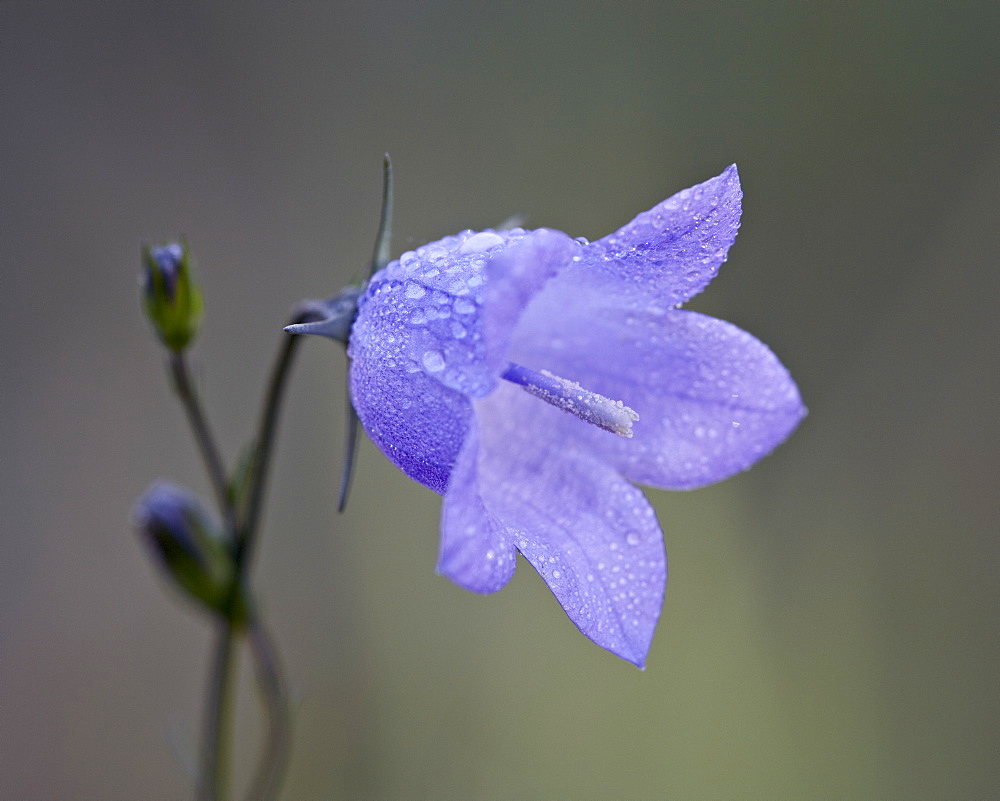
[349,165,805,667]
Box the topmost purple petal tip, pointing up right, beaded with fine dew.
[560,164,743,306]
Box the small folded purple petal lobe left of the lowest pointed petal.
[437,418,517,593]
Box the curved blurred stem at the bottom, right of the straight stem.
[247,616,291,801]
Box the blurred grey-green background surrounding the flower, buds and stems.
[0,0,1000,801]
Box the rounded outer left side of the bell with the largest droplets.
[348,229,578,494]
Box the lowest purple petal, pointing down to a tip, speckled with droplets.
[475,384,666,667]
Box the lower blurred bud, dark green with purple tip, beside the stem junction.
[132,482,234,615]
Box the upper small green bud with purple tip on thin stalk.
[142,242,201,351]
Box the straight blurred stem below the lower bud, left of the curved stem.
[198,617,238,801]
